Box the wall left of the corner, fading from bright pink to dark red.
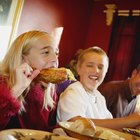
[18,0,93,66]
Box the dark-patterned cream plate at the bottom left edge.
[0,129,76,140]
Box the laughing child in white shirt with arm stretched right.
[57,46,140,129]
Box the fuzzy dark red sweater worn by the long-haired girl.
[0,77,58,131]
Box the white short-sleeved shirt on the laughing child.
[57,82,113,122]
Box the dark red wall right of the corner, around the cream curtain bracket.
[86,0,140,51]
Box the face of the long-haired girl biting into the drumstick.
[23,36,59,70]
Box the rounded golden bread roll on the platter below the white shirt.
[70,118,96,136]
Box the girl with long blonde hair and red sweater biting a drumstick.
[0,30,59,131]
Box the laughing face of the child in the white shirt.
[77,52,108,91]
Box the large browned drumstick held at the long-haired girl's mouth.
[37,67,76,84]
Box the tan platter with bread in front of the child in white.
[59,120,140,140]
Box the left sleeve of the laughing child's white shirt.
[57,89,87,122]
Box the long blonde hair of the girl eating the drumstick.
[0,30,54,109]
